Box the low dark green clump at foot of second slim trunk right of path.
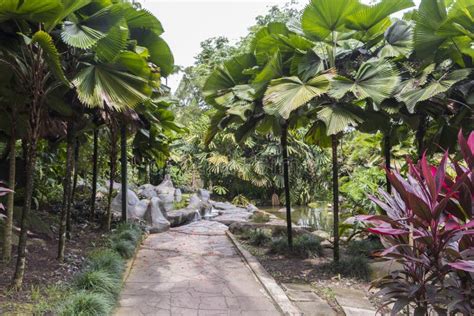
[320,256,371,281]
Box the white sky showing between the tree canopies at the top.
[139,0,419,91]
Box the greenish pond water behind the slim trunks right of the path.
[259,202,333,232]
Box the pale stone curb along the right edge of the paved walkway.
[226,230,303,316]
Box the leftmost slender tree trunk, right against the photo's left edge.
[3,127,16,263]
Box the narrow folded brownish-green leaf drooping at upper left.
[31,31,71,86]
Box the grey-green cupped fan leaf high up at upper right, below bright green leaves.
[379,20,413,58]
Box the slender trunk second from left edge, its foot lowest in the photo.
[12,137,38,289]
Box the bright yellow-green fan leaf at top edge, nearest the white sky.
[301,0,360,40]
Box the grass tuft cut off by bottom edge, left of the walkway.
[58,291,113,316]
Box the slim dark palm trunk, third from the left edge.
[57,122,74,262]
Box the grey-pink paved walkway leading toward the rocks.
[116,221,280,316]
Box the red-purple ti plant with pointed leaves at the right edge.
[360,132,474,315]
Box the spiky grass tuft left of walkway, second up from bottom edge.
[74,270,121,298]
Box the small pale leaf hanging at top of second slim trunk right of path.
[318,104,363,135]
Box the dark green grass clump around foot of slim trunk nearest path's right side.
[270,234,323,258]
